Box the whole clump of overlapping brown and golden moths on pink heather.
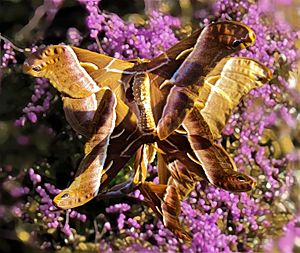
[19,21,269,239]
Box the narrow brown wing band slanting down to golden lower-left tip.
[54,89,117,209]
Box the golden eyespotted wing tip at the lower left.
[53,188,95,209]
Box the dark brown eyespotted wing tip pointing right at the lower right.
[217,171,256,192]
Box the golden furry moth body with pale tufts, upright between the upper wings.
[133,73,156,133]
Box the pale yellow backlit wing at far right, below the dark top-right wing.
[199,57,272,140]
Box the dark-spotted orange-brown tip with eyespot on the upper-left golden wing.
[23,45,64,77]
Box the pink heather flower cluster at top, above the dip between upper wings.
[80,1,180,59]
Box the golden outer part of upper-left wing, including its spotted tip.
[23,45,100,98]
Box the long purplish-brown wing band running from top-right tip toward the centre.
[157,21,255,139]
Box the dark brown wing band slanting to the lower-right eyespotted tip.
[183,104,254,191]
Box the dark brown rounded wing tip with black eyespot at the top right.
[207,21,256,53]
